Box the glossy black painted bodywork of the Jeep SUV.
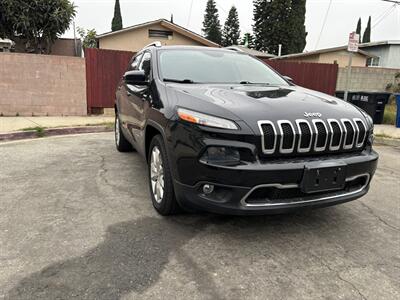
[116,46,378,214]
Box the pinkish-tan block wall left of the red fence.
[0,53,87,116]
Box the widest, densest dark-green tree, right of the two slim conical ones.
[253,0,307,54]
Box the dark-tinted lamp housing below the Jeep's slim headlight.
[200,147,240,166]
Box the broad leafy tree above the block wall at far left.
[0,0,76,53]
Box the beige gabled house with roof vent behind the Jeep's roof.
[97,19,220,52]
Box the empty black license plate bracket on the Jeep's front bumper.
[300,162,346,193]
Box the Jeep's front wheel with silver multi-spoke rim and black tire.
[148,135,180,216]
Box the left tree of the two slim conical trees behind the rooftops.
[203,0,222,44]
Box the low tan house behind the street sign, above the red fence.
[272,46,377,67]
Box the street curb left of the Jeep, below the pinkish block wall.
[0,126,113,142]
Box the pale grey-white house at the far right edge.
[359,40,400,69]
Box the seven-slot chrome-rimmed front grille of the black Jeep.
[258,119,367,155]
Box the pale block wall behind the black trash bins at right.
[336,67,400,92]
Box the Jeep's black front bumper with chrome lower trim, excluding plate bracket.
[168,120,378,215]
